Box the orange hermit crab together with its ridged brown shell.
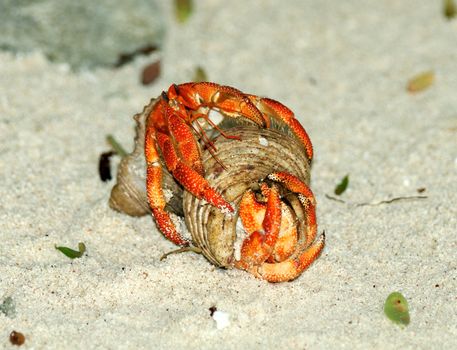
[110,82,325,282]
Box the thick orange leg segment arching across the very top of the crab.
[167,82,270,128]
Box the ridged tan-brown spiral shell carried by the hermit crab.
[109,100,310,268]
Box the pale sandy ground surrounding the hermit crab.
[0,0,457,349]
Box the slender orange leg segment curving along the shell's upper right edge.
[247,95,313,160]
